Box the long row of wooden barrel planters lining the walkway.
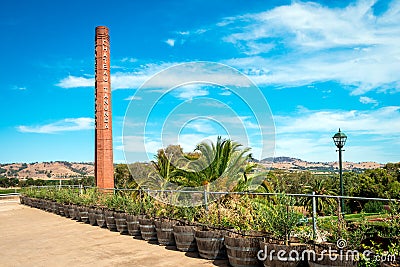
[21,196,355,267]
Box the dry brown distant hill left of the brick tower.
[0,161,94,180]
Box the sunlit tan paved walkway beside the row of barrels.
[0,199,228,267]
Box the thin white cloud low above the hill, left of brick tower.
[17,118,94,134]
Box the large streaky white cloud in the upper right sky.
[218,0,400,94]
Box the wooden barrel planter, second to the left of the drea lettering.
[195,229,227,260]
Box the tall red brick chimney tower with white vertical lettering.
[94,26,114,188]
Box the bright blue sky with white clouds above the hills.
[0,0,400,163]
